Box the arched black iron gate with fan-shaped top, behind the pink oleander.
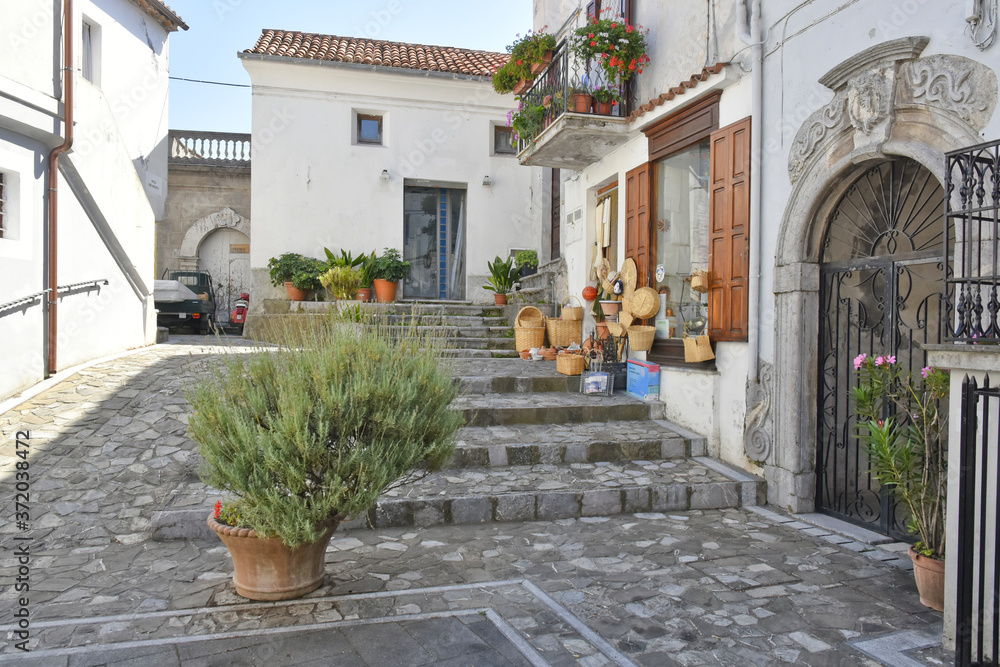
[816,157,944,536]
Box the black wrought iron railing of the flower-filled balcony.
[517,40,632,153]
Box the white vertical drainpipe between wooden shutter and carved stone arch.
[736,0,764,382]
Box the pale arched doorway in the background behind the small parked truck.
[198,227,250,322]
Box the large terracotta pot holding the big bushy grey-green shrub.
[208,514,340,600]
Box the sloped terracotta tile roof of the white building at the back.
[244,30,509,76]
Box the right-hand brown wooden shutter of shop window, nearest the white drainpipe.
[708,118,751,341]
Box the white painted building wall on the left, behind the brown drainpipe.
[0,0,182,397]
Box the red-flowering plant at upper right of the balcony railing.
[572,16,649,83]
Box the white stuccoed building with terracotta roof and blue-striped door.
[240,30,544,308]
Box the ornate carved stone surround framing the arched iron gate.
[765,37,997,512]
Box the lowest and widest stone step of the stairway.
[346,459,764,528]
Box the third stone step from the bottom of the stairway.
[452,392,662,426]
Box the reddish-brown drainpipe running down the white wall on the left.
[45,0,73,377]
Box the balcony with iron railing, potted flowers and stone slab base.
[493,16,649,169]
